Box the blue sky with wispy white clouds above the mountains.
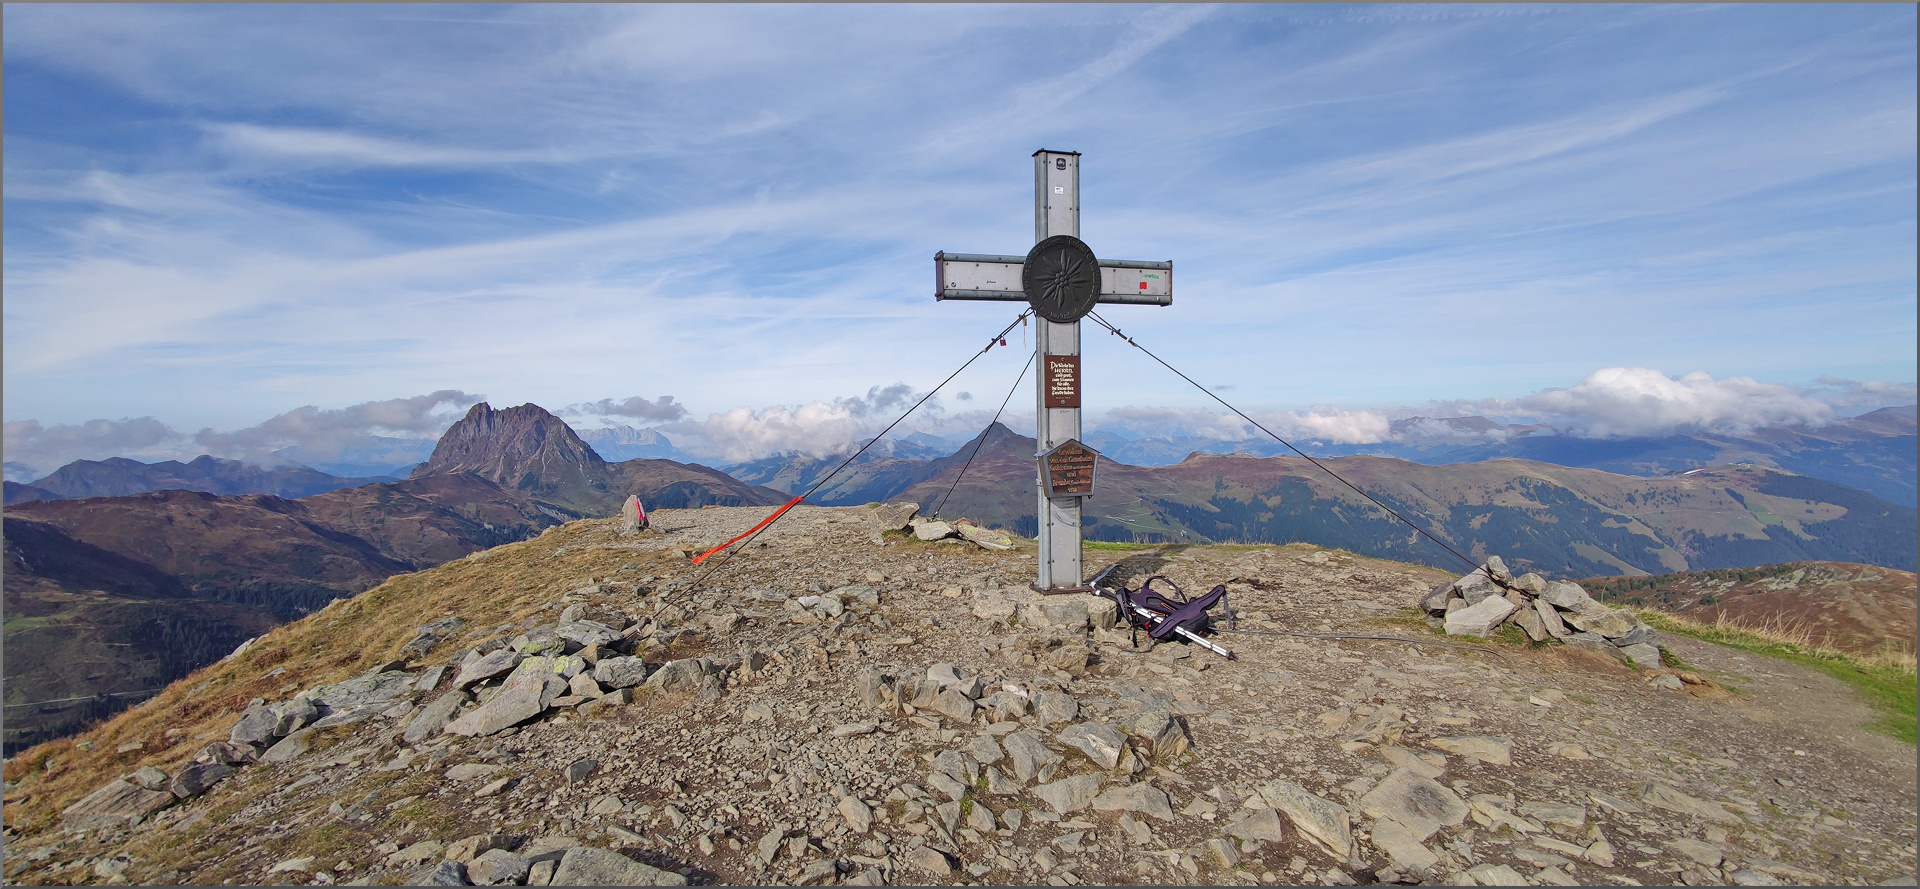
[4,4,1916,469]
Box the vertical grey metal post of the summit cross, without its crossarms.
[1033,150,1083,589]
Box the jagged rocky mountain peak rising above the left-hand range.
[413,401,607,490]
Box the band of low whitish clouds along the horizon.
[6,367,1914,482]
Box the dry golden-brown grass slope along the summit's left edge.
[4,520,685,833]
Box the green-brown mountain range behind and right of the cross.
[735,424,1916,576]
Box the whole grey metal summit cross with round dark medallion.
[933,148,1173,593]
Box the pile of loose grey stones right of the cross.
[1421,555,1661,668]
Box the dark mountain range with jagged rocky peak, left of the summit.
[4,403,785,749]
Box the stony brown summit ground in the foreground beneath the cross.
[4,505,1916,885]
